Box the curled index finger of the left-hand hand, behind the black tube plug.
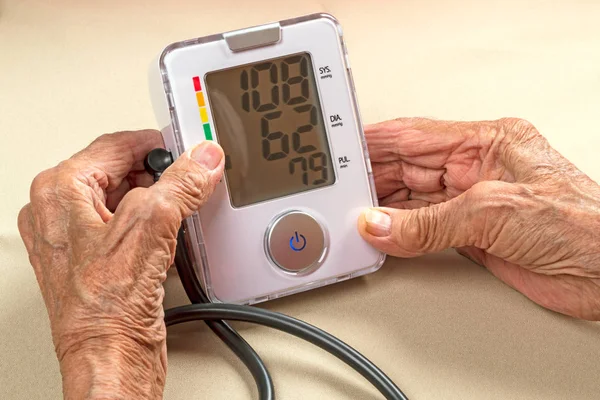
[71,129,164,190]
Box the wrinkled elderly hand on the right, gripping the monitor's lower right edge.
[359,119,600,320]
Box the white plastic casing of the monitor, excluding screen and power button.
[150,14,385,304]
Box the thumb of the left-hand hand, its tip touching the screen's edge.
[111,140,225,238]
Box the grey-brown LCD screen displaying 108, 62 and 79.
[206,53,335,207]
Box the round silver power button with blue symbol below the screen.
[265,211,326,273]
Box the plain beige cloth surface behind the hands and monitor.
[0,0,600,400]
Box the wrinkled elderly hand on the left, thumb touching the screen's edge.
[19,131,224,399]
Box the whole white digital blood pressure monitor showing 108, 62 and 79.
[151,14,384,304]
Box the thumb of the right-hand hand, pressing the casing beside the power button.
[359,181,512,257]
